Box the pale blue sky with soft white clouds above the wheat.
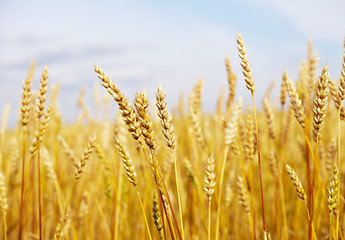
[0,0,345,122]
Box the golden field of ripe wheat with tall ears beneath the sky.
[0,33,345,240]
